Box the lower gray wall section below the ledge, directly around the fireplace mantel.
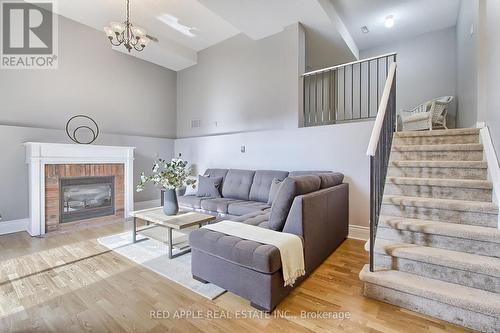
[0,125,174,223]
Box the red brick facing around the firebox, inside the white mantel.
[45,164,125,232]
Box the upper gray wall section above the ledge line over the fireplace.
[0,16,176,138]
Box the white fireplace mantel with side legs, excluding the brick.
[24,142,135,236]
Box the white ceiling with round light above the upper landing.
[330,0,460,50]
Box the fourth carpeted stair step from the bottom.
[381,195,498,228]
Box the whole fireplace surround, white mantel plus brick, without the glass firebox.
[24,142,135,236]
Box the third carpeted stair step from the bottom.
[377,215,500,258]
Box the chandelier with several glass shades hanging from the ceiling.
[104,0,149,52]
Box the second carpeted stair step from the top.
[391,144,483,161]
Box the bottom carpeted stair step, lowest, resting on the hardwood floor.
[359,265,500,333]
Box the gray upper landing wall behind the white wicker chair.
[360,27,457,126]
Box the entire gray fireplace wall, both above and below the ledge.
[0,17,176,221]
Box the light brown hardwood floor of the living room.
[0,219,468,332]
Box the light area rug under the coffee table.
[97,227,225,300]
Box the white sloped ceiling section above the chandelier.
[52,0,239,70]
